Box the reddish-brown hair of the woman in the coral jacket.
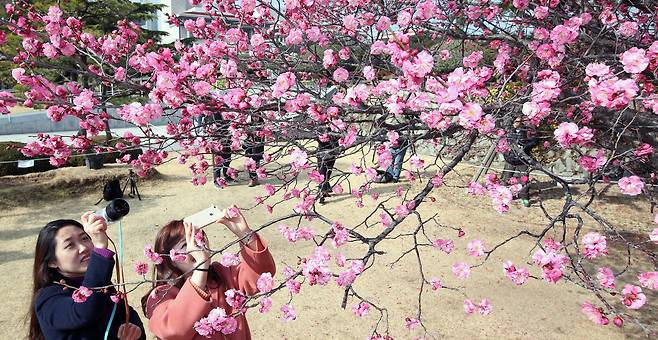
[142,220,217,315]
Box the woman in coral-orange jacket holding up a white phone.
[142,207,276,340]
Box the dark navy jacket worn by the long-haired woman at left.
[34,251,146,340]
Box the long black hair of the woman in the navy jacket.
[26,220,84,340]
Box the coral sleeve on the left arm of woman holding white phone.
[146,279,212,340]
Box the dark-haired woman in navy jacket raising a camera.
[28,213,146,340]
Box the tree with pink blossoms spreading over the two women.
[0,0,658,338]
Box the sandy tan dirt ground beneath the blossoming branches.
[0,153,658,339]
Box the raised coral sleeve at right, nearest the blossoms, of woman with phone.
[230,234,276,295]
